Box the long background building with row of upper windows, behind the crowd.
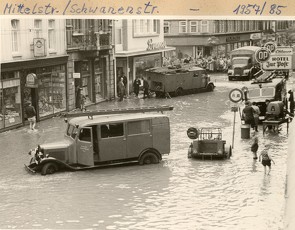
[164,20,289,59]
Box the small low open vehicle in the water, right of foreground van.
[187,127,232,160]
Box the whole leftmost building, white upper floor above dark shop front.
[0,18,68,131]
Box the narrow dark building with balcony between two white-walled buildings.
[66,19,115,110]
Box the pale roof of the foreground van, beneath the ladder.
[69,113,167,127]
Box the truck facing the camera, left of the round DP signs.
[227,46,261,81]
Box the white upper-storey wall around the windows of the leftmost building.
[0,18,66,63]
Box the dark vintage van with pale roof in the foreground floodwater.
[26,107,173,175]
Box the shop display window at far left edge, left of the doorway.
[0,71,22,129]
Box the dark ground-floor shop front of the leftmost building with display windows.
[0,57,67,131]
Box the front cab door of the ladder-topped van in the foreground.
[77,127,94,166]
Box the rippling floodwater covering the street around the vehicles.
[0,76,288,230]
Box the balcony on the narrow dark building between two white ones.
[67,31,112,51]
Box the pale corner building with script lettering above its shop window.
[113,19,175,94]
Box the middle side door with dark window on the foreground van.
[98,123,127,161]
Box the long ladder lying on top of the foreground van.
[61,105,173,119]
